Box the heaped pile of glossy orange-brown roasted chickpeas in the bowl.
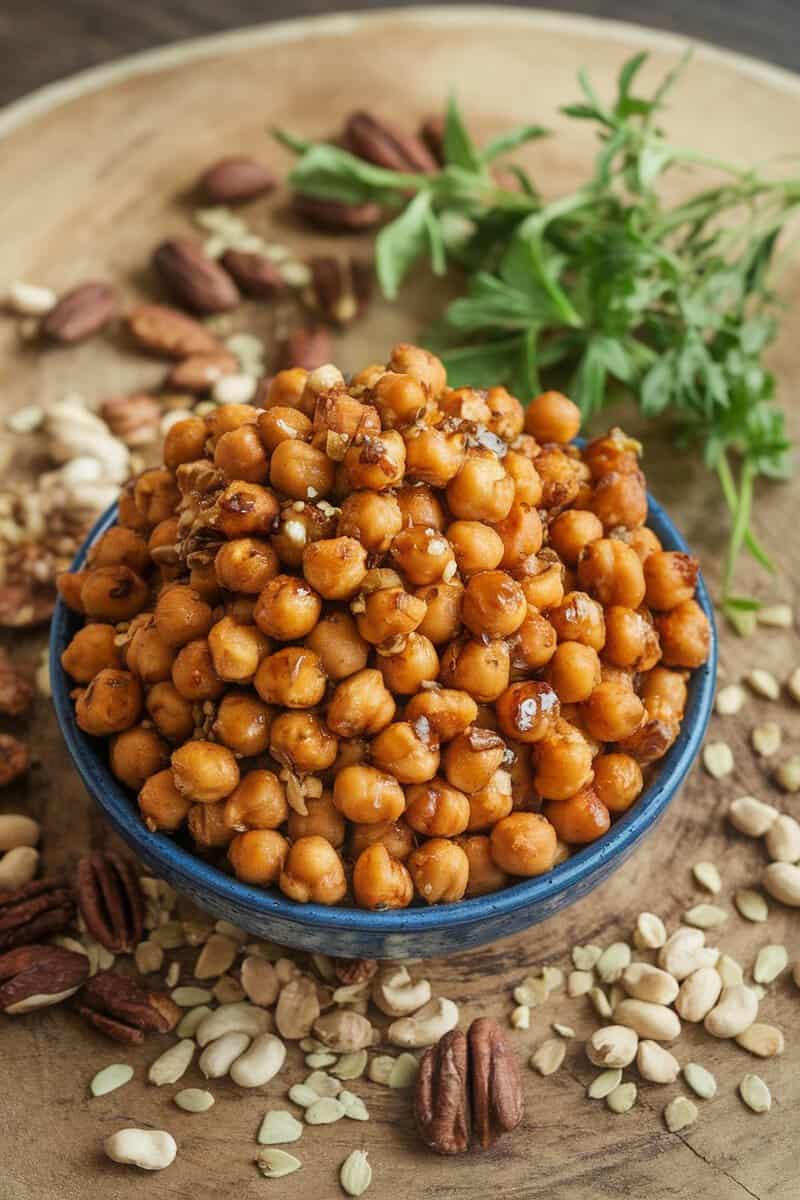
[59,344,710,910]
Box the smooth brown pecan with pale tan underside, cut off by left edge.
[0,946,89,1016]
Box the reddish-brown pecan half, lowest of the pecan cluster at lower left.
[78,971,181,1044]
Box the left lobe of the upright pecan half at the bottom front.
[414,1030,470,1154]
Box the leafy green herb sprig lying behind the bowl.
[278,54,800,622]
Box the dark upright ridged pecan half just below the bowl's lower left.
[76,851,145,954]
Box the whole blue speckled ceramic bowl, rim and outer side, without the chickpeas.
[50,498,716,959]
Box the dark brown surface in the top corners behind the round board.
[0,0,800,103]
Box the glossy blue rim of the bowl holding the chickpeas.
[49,493,717,935]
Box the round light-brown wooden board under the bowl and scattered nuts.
[0,8,800,1200]
